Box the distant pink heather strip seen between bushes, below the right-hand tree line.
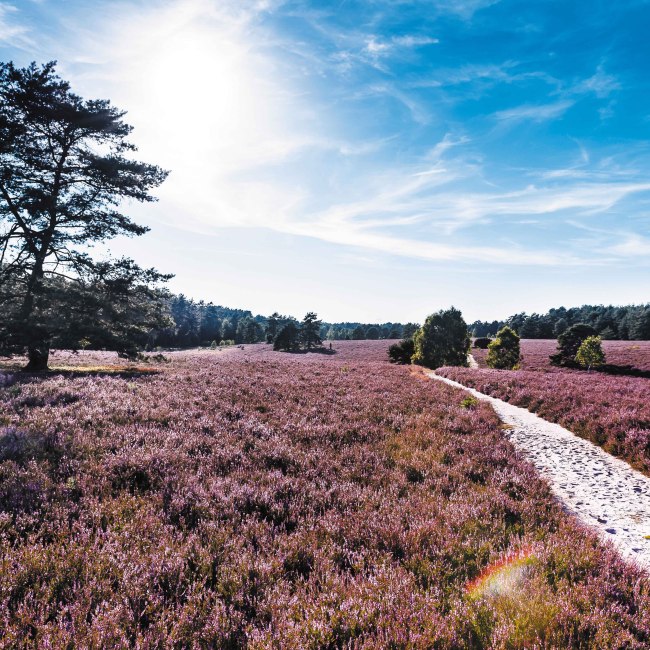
[471,339,650,372]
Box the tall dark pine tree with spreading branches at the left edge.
[0,63,170,371]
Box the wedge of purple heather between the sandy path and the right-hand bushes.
[437,368,650,475]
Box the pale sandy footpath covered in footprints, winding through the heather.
[427,372,650,570]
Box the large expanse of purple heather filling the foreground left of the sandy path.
[0,342,650,649]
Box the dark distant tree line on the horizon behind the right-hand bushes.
[469,303,650,341]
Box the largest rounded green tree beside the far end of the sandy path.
[413,307,470,368]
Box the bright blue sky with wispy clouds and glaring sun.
[0,0,650,322]
